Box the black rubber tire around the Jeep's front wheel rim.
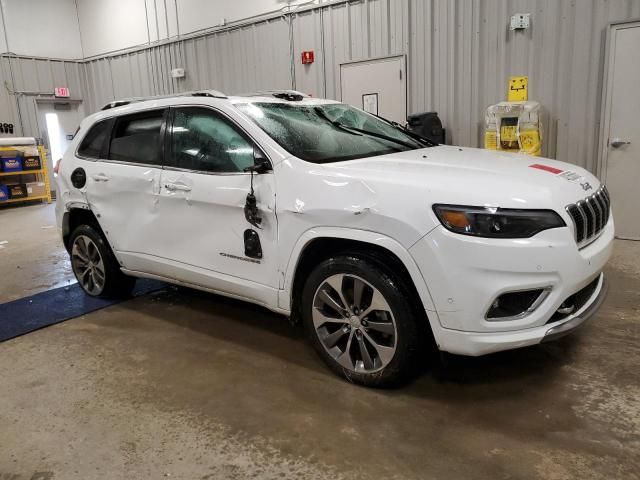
[301,255,421,387]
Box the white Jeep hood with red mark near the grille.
[324,145,600,210]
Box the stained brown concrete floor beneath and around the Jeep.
[0,206,640,480]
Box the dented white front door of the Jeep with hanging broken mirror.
[158,107,278,303]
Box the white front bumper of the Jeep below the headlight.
[410,219,614,356]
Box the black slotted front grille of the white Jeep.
[567,185,611,247]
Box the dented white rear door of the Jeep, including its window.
[78,109,168,273]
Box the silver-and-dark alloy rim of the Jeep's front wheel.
[312,274,397,373]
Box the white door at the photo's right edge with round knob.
[603,23,640,240]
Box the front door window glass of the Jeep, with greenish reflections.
[167,107,254,173]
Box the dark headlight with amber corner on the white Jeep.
[433,205,566,238]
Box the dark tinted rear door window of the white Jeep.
[109,110,164,165]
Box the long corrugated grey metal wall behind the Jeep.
[0,0,640,171]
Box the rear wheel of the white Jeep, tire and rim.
[69,225,136,298]
